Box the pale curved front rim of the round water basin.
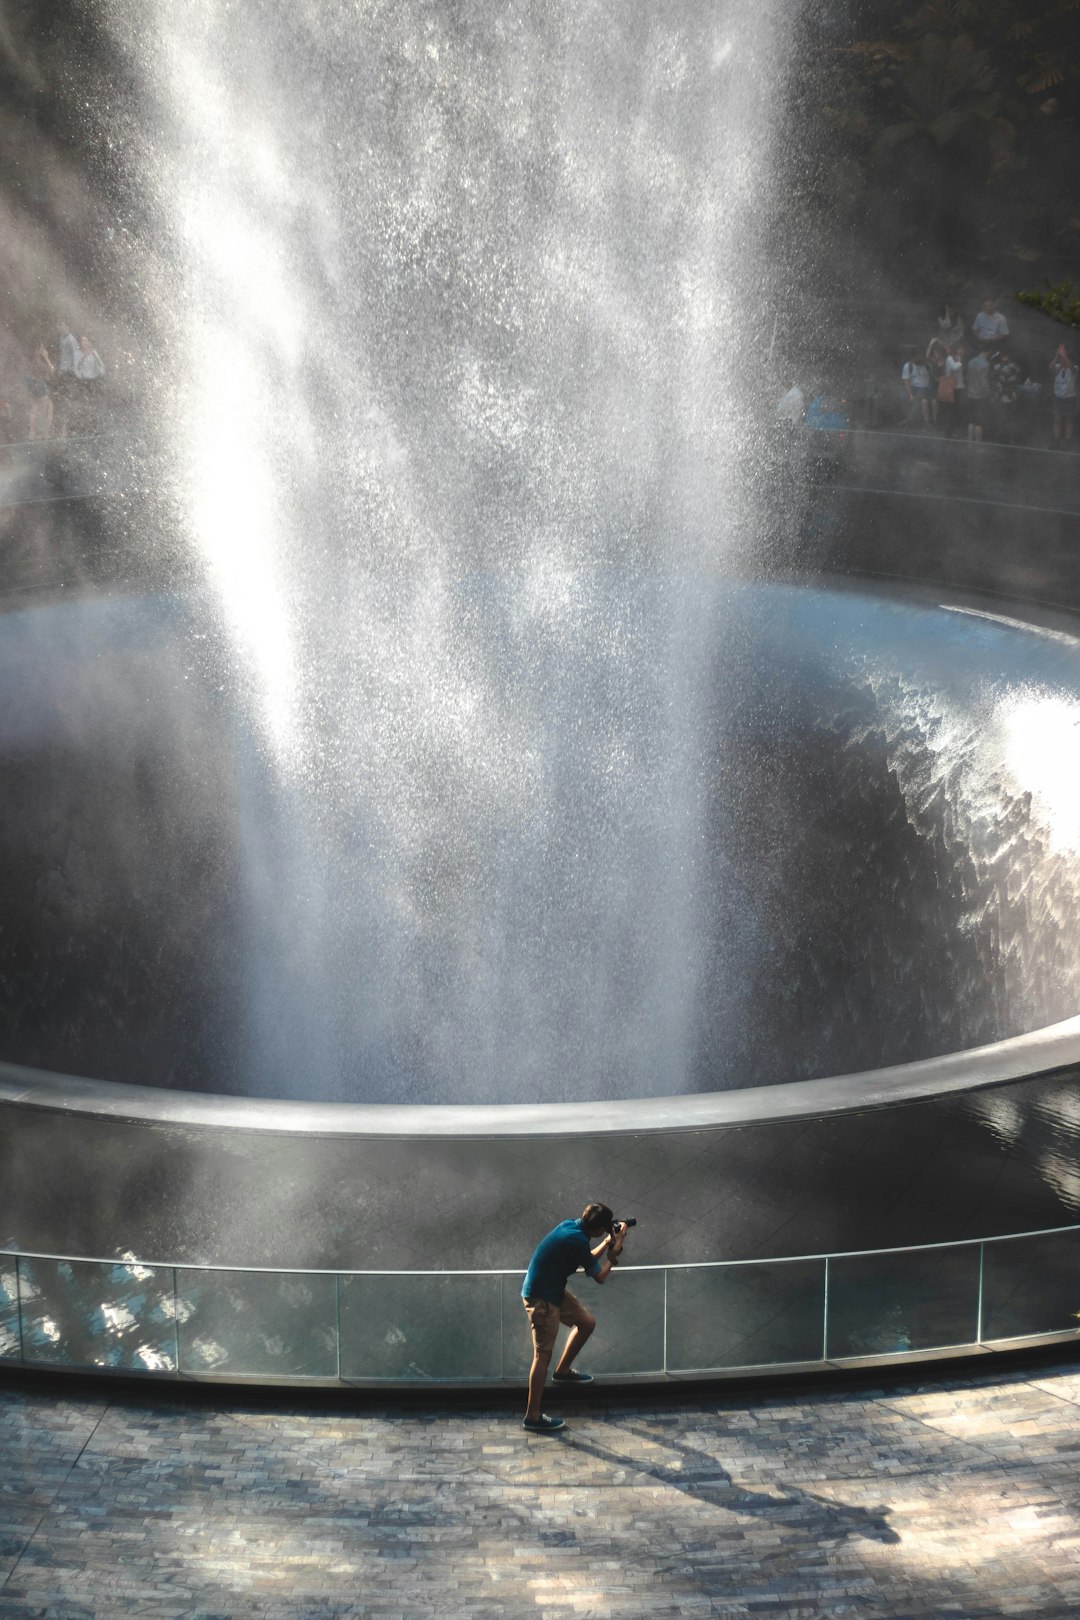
[0,1017,1080,1139]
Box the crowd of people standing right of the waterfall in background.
[777,298,1080,447]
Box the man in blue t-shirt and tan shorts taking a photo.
[521,1204,627,1434]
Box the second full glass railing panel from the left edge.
[176,1270,337,1379]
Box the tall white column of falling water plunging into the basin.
[93,0,790,1100]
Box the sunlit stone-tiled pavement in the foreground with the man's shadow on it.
[0,1351,1080,1620]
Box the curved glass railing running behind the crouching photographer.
[0,1226,1080,1385]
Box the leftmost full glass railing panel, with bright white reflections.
[19,1259,176,1372]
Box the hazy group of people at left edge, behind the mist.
[0,319,105,444]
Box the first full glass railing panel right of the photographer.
[667,1260,826,1372]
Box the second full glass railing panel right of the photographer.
[829,1244,978,1359]
